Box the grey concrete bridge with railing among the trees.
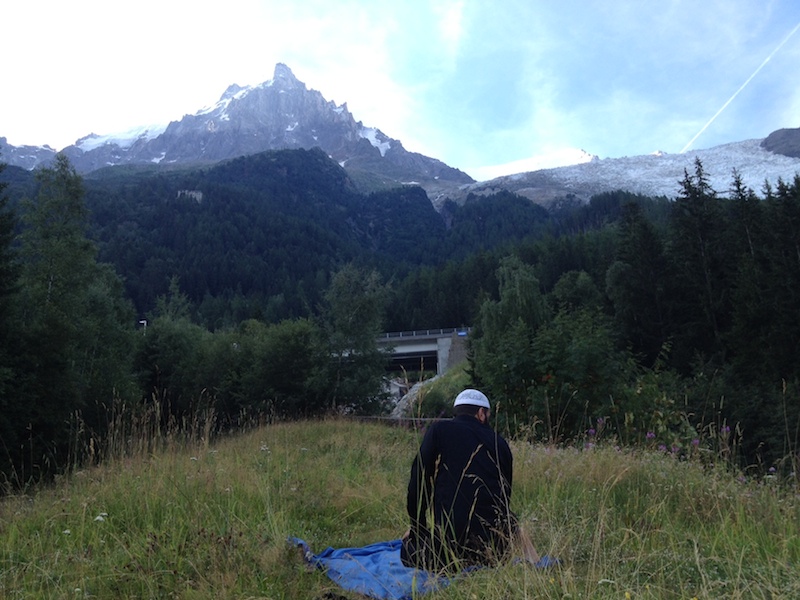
[378,327,469,375]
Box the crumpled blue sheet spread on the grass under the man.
[289,538,450,600]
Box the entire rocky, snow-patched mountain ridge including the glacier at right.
[0,63,800,210]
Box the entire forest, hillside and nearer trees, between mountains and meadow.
[0,150,800,488]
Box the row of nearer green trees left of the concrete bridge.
[0,155,386,486]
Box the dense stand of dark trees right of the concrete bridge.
[471,160,800,473]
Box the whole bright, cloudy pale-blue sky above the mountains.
[0,0,800,179]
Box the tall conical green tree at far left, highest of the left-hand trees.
[17,154,134,476]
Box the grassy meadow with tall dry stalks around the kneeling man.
[0,420,800,600]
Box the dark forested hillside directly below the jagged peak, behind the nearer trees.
[54,150,547,327]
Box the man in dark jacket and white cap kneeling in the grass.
[400,389,539,571]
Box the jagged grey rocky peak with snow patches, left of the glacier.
[3,64,474,192]
